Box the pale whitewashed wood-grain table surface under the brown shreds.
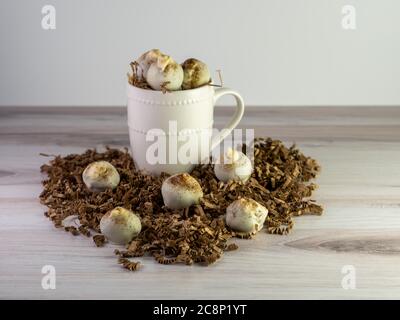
[0,107,400,299]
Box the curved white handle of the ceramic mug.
[210,88,244,151]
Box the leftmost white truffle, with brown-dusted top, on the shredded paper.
[82,161,120,192]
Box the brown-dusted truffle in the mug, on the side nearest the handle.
[182,58,211,90]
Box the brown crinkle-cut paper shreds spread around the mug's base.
[40,138,322,271]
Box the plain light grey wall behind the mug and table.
[0,0,400,106]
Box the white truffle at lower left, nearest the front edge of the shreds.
[100,207,142,244]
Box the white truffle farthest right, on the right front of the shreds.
[225,198,268,234]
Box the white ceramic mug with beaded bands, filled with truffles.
[127,84,244,175]
